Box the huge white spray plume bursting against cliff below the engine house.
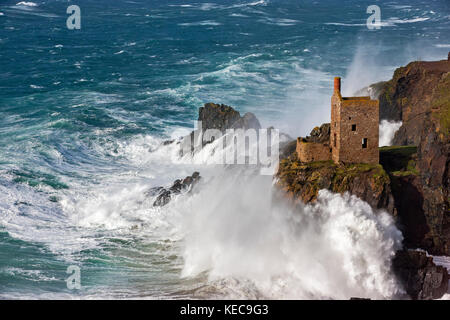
[176,171,402,299]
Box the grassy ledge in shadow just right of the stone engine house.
[380,146,419,176]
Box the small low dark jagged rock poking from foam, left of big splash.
[151,172,201,207]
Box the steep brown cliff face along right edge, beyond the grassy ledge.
[378,60,450,255]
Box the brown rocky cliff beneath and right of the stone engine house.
[276,55,450,299]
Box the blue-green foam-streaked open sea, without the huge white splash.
[0,0,450,298]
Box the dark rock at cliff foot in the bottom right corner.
[392,250,449,300]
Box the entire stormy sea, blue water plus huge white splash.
[0,0,450,299]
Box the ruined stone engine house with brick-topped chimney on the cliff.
[296,77,379,164]
